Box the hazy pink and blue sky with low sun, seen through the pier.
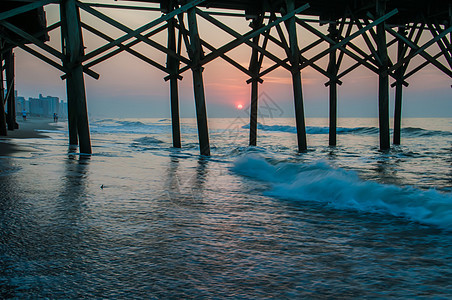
[15,5,452,118]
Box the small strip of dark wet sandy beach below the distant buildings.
[0,117,58,156]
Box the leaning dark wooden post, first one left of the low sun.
[187,8,210,156]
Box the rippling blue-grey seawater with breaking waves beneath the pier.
[0,117,452,299]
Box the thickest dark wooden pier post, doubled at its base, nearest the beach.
[60,0,92,154]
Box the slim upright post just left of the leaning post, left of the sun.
[167,12,181,148]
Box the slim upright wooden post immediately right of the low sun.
[249,16,263,146]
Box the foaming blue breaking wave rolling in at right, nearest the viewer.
[233,154,452,230]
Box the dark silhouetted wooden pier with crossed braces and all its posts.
[0,0,452,155]
